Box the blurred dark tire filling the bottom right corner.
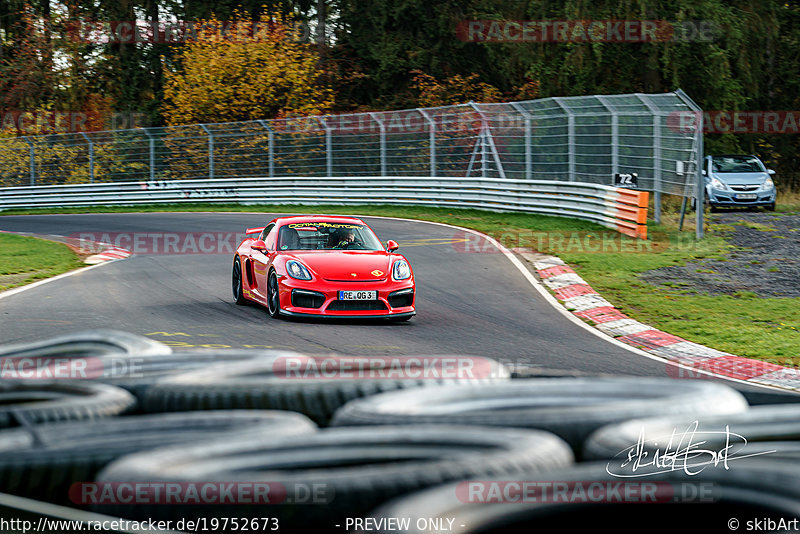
[366,459,800,534]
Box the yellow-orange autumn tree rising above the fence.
[163,13,333,125]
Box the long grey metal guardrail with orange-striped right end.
[0,176,648,239]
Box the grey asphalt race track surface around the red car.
[0,213,780,384]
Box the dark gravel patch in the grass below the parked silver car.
[640,211,800,297]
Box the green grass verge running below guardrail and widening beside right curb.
[2,204,800,365]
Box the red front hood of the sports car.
[292,250,392,282]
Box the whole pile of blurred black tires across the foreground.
[0,332,800,533]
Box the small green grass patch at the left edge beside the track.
[0,234,84,291]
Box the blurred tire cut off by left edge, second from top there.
[0,381,136,428]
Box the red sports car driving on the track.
[233,215,416,321]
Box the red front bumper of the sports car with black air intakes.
[278,276,416,319]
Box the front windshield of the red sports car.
[278,221,383,251]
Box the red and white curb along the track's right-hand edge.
[533,256,800,391]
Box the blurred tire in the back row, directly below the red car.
[141,355,510,426]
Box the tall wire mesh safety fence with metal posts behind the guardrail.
[0,91,702,202]
